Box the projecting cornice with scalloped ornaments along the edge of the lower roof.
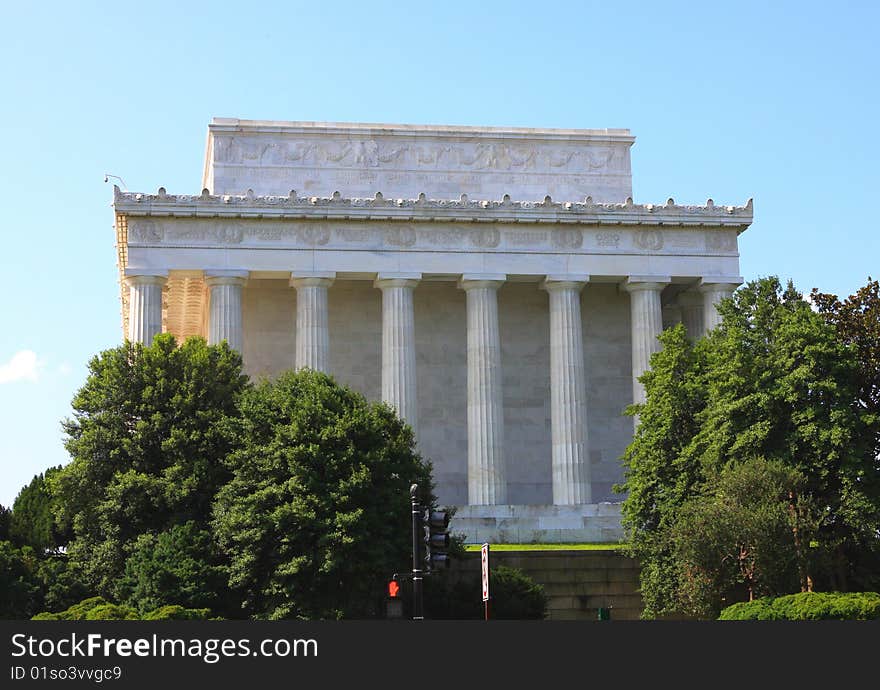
[113,186,754,232]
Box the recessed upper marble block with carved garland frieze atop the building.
[205,127,632,201]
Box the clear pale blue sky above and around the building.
[0,0,880,505]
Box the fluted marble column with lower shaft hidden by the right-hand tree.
[621,276,670,408]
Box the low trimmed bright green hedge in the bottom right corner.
[718,592,880,621]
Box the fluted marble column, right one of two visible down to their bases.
[542,276,592,505]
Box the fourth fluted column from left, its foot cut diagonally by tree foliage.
[374,273,422,436]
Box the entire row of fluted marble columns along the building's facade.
[126,270,737,505]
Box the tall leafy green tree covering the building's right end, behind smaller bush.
[621,278,880,616]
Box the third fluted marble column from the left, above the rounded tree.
[290,271,336,372]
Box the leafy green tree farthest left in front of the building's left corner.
[50,334,247,597]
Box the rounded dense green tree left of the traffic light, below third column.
[214,370,431,619]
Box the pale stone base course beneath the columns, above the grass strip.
[449,502,623,544]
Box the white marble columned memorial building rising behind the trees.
[114,119,752,542]
